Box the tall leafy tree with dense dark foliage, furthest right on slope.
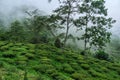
[75,0,115,50]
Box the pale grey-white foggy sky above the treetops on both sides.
[0,0,120,35]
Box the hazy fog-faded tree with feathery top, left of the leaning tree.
[24,9,47,43]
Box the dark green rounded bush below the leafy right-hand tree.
[95,50,109,61]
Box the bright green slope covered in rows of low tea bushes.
[0,41,120,80]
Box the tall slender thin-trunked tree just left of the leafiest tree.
[54,0,79,47]
